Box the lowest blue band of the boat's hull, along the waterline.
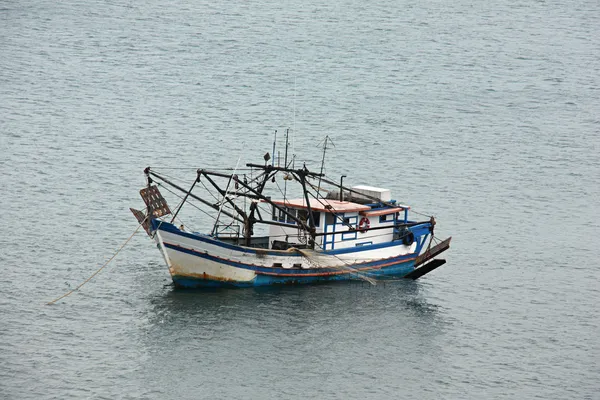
[173,260,414,289]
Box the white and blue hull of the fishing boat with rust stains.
[152,220,420,287]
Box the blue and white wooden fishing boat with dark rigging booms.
[131,135,451,288]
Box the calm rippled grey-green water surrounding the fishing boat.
[0,0,600,399]
